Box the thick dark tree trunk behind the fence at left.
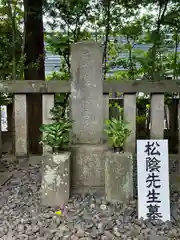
[24,0,45,154]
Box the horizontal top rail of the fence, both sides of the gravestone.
[0,80,180,94]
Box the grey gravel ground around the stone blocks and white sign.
[0,162,180,240]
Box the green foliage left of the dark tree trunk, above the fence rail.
[0,3,22,80]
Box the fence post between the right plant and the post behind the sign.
[124,93,136,154]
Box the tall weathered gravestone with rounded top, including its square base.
[71,41,106,190]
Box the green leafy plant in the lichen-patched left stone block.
[40,119,72,152]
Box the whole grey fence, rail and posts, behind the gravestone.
[0,80,180,156]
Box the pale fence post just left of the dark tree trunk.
[14,94,28,157]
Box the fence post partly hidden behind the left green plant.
[42,94,54,154]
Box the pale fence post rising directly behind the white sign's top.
[150,94,164,139]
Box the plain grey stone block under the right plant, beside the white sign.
[105,151,133,203]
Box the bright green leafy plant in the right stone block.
[104,118,131,151]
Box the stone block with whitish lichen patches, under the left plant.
[41,152,71,207]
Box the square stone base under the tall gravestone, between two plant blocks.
[71,144,107,190]
